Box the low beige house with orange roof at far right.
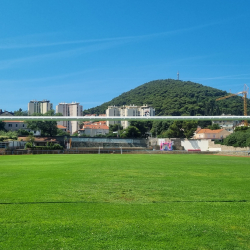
[193,129,231,140]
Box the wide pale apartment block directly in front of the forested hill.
[106,104,155,129]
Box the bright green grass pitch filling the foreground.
[0,155,250,250]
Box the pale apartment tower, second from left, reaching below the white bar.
[56,102,82,135]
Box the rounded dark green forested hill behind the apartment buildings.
[83,79,250,115]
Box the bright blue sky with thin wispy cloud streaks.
[0,0,250,111]
